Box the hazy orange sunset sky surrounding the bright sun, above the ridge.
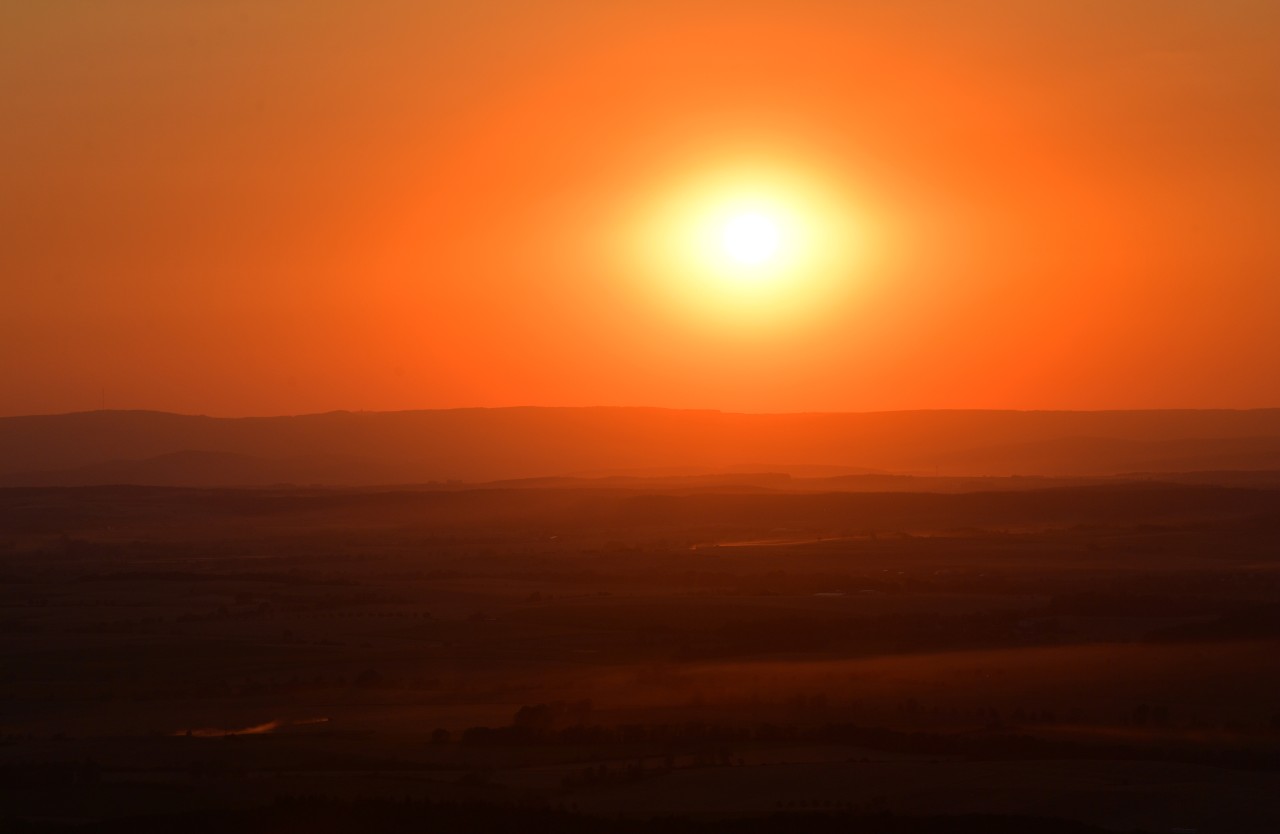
[0,0,1280,416]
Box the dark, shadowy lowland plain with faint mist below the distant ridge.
[0,478,1280,834]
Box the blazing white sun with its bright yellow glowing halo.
[631,166,865,329]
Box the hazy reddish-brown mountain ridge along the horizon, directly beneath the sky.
[0,408,1280,486]
